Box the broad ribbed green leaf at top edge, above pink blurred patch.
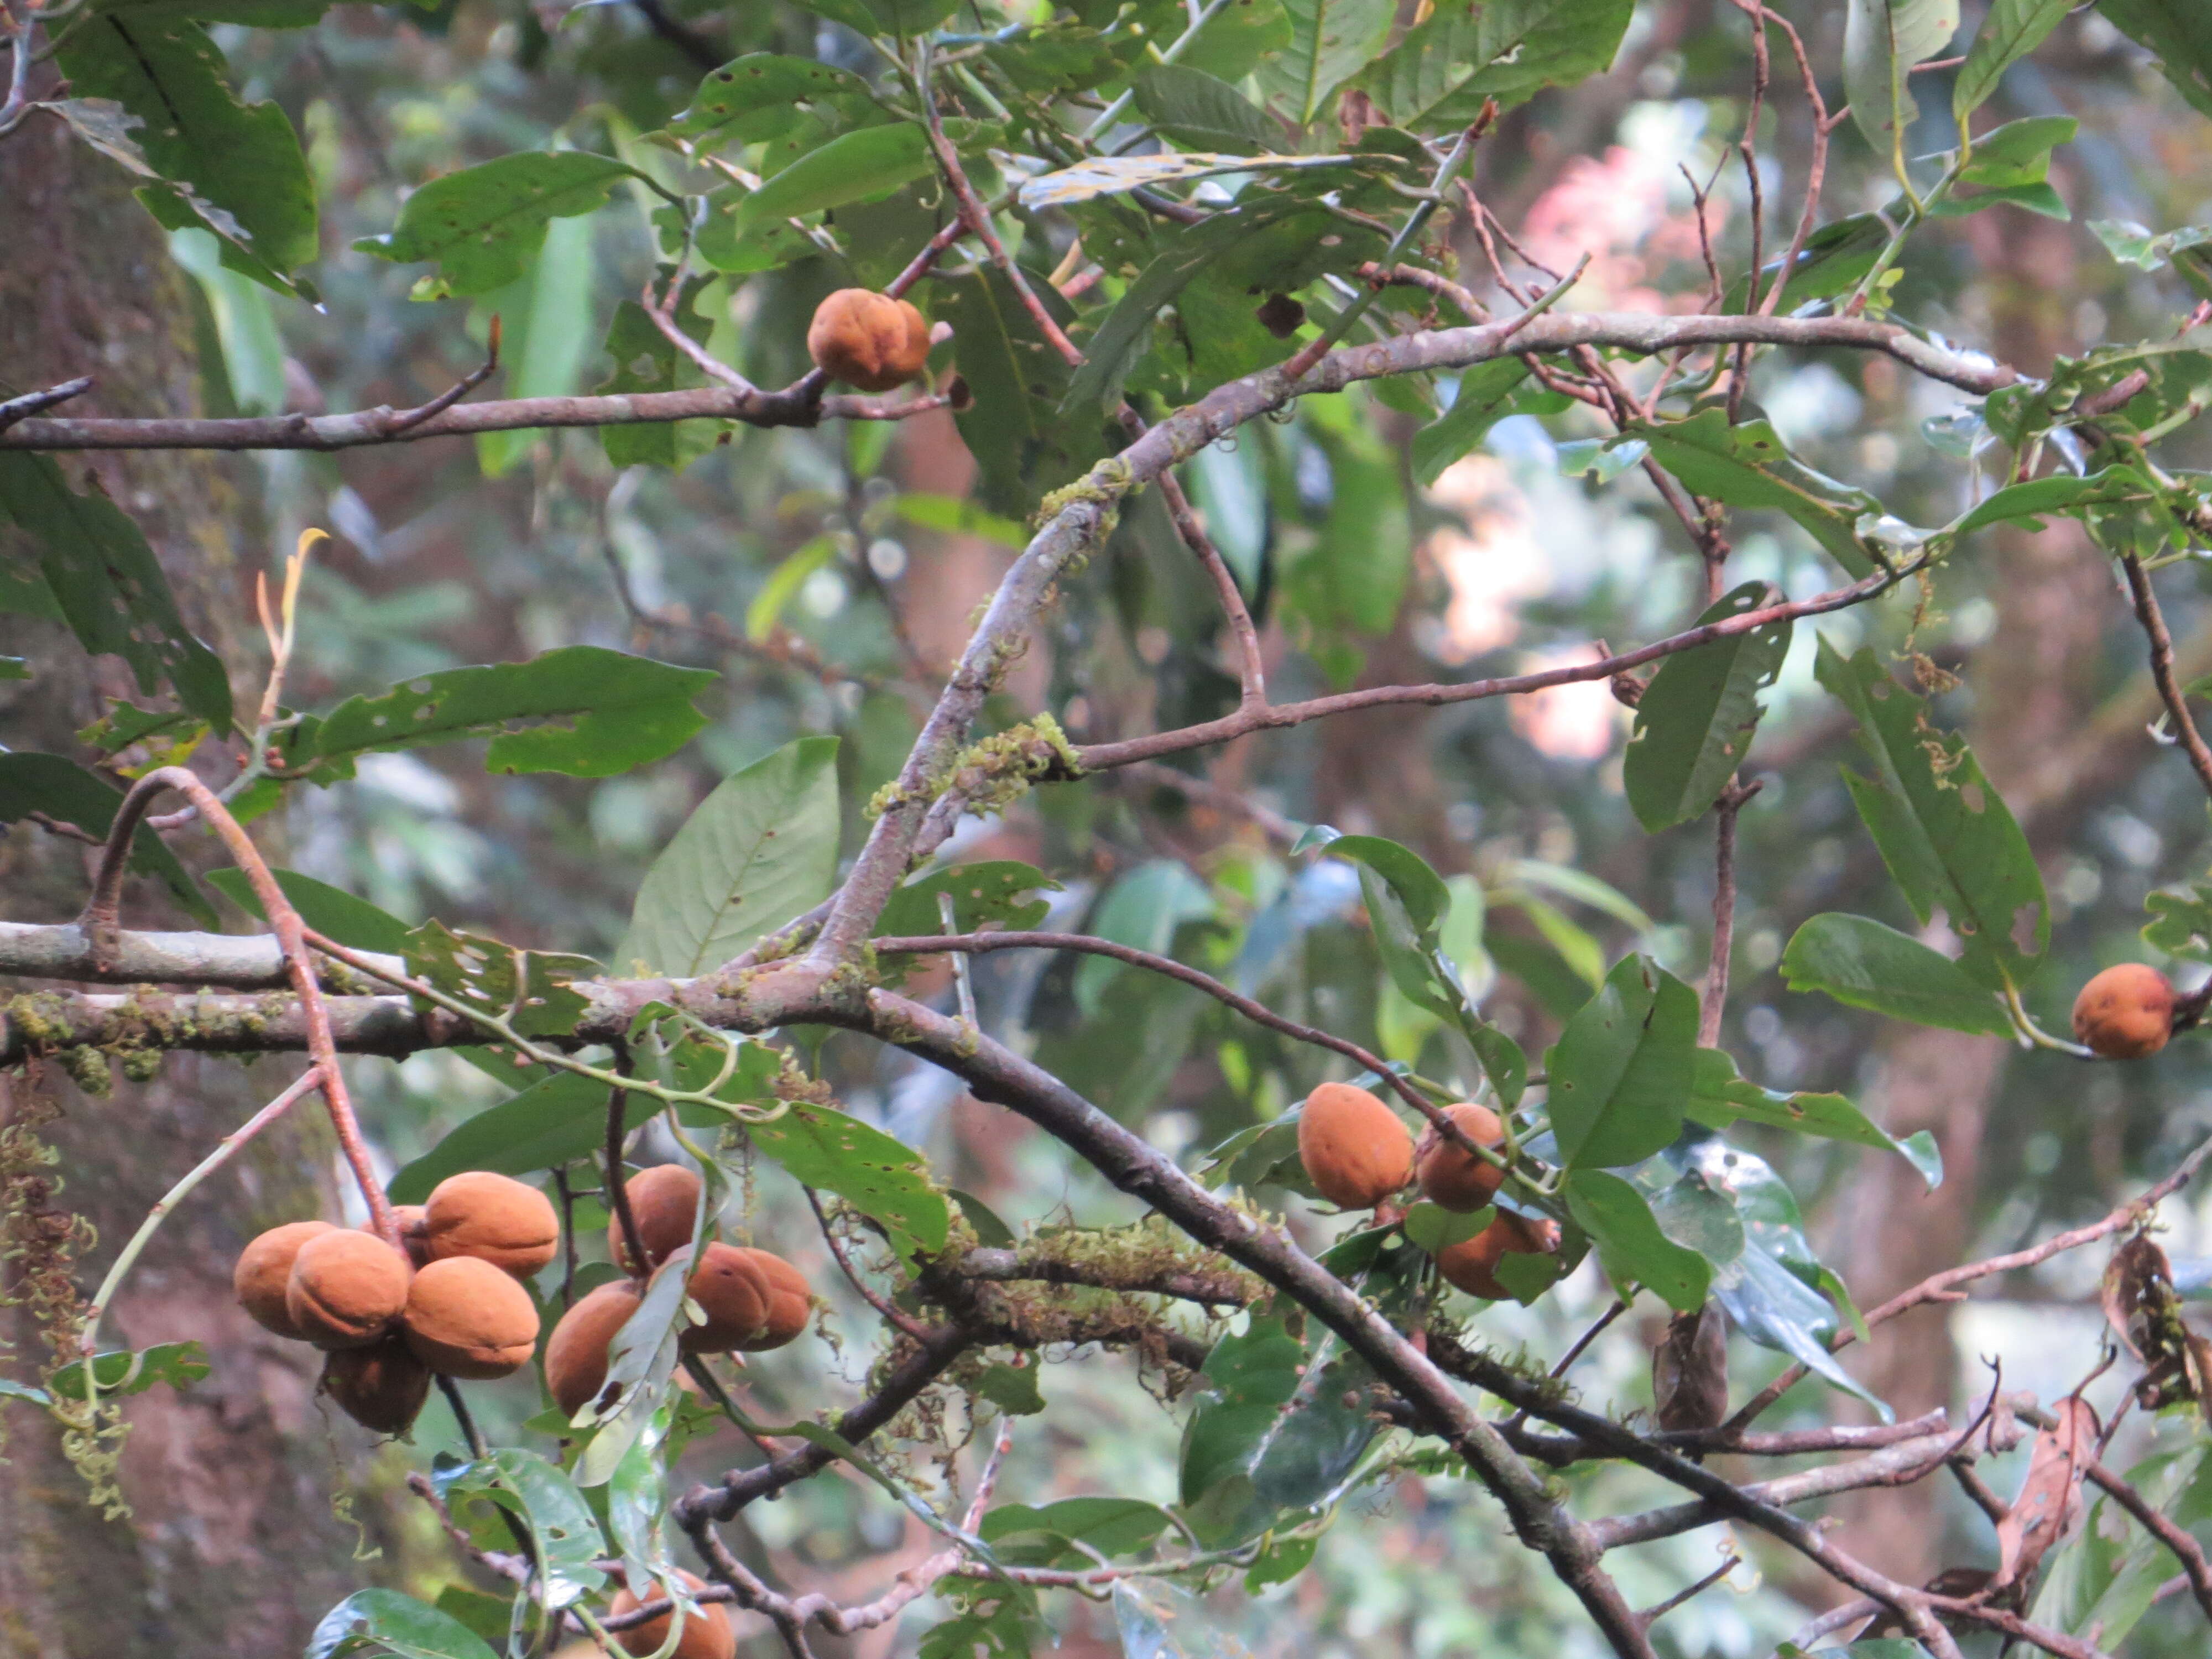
[1360,0,1635,133]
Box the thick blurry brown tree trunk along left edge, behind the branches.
[0,117,416,1659]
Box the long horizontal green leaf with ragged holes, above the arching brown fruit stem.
[307,646,717,781]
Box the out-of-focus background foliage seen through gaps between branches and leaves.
[13,0,2212,1657]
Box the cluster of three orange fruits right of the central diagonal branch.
[1298,1084,1559,1303]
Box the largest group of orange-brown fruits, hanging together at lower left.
[232,1164,814,1433]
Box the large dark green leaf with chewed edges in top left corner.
[55,13,316,299]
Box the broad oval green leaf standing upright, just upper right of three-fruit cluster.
[1546,956,1697,1177]
